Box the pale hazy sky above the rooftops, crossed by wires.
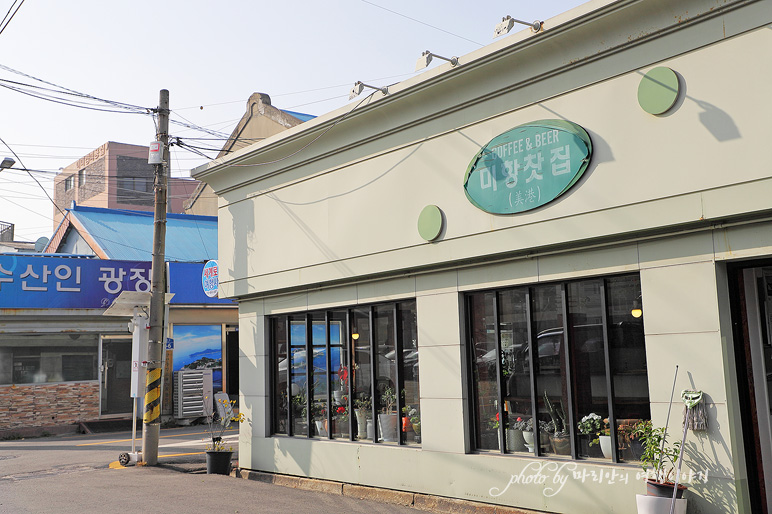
[0,0,585,241]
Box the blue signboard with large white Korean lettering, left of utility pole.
[0,254,150,309]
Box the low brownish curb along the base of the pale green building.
[231,469,544,514]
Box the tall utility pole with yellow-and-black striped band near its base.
[142,89,169,466]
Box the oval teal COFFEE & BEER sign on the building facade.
[464,120,592,214]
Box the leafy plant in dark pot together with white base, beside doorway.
[631,420,687,514]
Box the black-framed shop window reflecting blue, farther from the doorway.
[269,301,421,445]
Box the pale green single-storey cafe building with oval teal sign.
[194,0,772,514]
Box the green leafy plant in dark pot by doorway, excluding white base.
[630,420,687,498]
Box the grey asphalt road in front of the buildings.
[0,427,417,514]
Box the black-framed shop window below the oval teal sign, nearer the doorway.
[466,275,651,462]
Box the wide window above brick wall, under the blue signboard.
[0,334,99,384]
